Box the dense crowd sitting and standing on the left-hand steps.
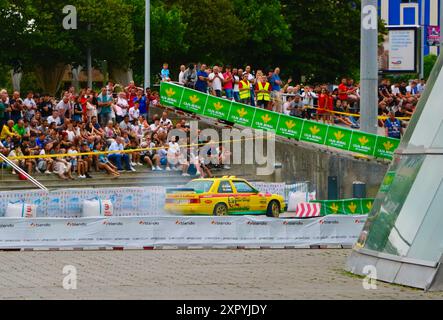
[0,82,226,180]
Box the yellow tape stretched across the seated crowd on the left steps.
[6,137,265,162]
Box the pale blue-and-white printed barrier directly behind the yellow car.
[0,182,308,218]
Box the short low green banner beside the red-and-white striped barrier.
[311,199,374,216]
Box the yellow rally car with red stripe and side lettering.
[165,176,285,218]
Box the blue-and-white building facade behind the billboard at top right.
[378,0,443,55]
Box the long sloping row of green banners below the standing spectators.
[160,82,400,160]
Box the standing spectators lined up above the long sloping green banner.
[172,63,426,138]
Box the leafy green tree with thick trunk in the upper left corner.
[0,0,134,94]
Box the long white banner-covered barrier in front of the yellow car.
[0,215,367,249]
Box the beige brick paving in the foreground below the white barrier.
[0,249,443,299]
